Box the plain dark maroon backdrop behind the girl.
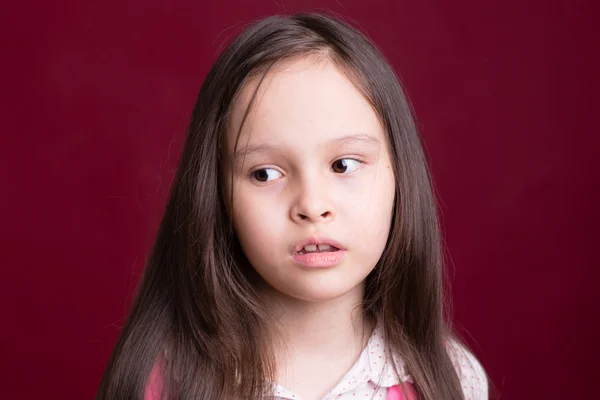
[0,0,600,399]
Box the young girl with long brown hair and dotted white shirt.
[98,10,487,400]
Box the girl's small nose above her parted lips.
[290,181,335,224]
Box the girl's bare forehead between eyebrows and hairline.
[227,57,383,152]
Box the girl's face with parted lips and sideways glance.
[225,58,395,301]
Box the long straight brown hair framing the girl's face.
[97,13,463,400]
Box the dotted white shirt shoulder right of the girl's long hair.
[446,339,488,400]
